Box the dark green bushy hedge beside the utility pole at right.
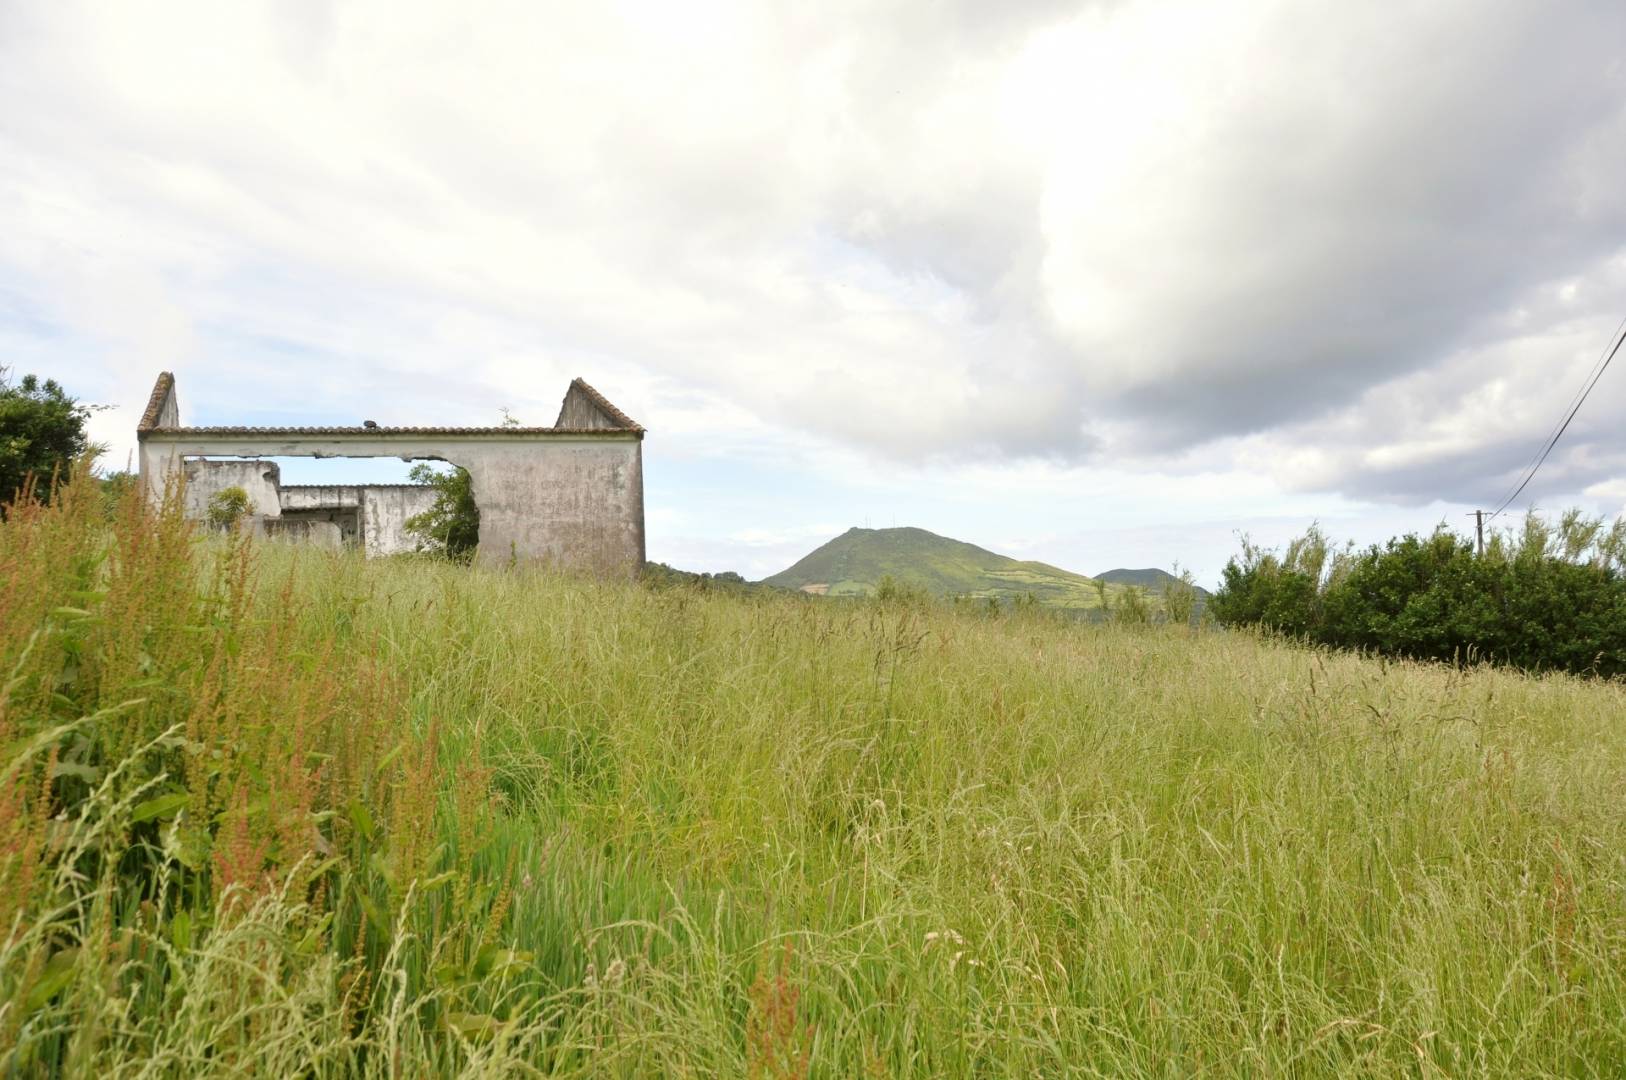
[1210,511,1626,675]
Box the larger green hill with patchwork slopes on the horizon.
[764,529,1101,610]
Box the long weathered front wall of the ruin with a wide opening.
[141,428,644,576]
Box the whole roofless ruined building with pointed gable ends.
[137,371,644,576]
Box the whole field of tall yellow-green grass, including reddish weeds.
[0,483,1626,1077]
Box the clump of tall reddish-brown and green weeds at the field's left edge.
[0,465,506,1075]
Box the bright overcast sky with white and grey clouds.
[0,0,1626,582]
